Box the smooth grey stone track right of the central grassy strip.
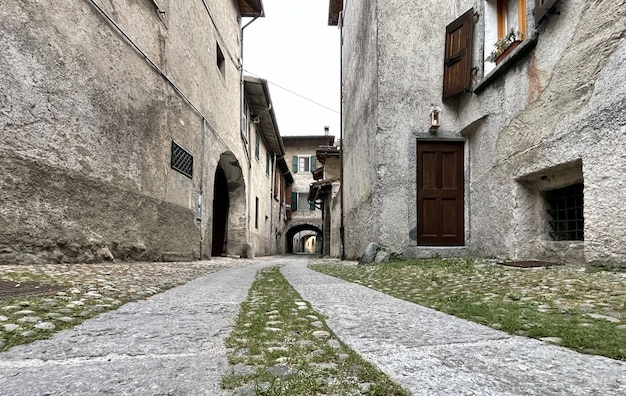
[282,259,626,395]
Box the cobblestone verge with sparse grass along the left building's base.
[0,262,230,352]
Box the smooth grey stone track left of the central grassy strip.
[0,261,272,396]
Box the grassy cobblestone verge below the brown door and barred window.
[310,258,626,360]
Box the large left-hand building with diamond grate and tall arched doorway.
[0,0,263,263]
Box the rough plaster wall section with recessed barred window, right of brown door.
[459,1,626,262]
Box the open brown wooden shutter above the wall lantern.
[443,8,474,100]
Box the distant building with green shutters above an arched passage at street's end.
[283,131,335,253]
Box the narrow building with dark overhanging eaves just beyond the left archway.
[244,76,294,255]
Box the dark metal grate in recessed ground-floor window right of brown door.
[548,183,585,241]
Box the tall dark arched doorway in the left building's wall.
[211,151,247,256]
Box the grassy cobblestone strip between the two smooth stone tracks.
[221,267,409,396]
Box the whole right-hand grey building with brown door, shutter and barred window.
[329,0,626,265]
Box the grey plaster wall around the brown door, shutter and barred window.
[343,0,626,262]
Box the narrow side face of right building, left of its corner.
[342,1,380,259]
